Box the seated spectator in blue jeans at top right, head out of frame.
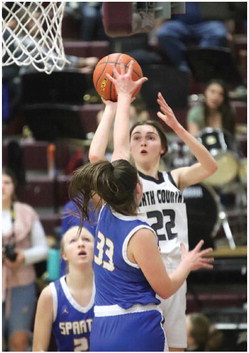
[157,2,229,71]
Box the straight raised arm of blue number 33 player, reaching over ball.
[107,61,148,161]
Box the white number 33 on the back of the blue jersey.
[94,232,114,271]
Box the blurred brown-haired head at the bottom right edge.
[186,313,223,352]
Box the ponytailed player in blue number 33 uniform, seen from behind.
[69,63,213,351]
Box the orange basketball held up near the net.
[93,53,143,102]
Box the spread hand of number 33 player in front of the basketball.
[106,60,148,96]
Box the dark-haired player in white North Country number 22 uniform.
[90,60,217,351]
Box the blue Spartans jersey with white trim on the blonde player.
[50,276,95,352]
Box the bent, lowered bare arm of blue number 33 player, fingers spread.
[128,228,213,299]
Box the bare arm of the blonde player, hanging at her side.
[32,286,53,352]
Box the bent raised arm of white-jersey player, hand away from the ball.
[157,93,217,190]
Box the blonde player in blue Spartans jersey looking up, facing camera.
[33,226,95,352]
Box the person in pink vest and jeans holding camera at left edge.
[2,169,48,352]
